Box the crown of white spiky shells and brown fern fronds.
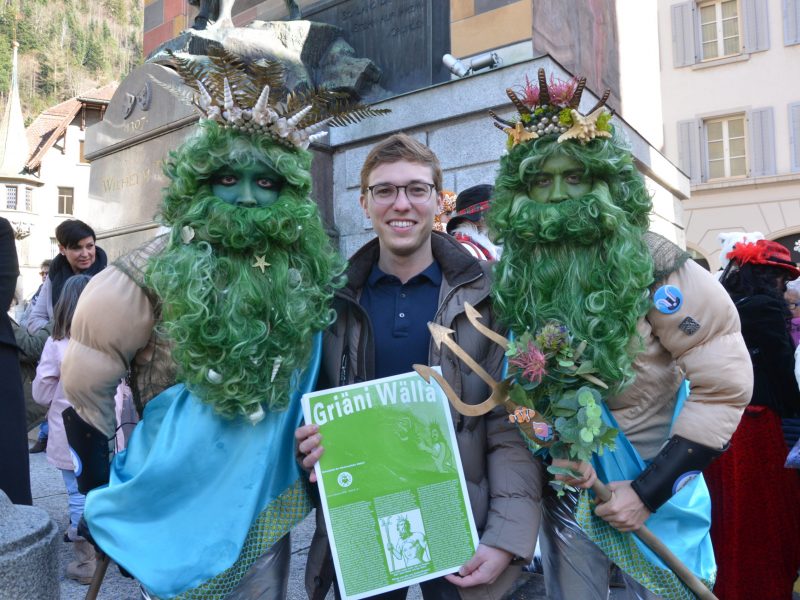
[154,49,390,149]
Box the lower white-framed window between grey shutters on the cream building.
[705,115,747,180]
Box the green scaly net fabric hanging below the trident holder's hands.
[575,492,716,600]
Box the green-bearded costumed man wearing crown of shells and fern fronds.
[62,49,386,599]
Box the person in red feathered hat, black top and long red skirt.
[701,240,800,600]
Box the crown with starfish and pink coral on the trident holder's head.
[489,69,612,148]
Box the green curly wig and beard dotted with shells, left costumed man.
[146,122,344,418]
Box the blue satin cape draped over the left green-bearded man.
[84,333,322,597]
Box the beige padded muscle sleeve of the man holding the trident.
[647,260,753,449]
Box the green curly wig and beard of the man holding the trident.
[488,138,653,392]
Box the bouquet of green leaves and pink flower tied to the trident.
[506,321,617,495]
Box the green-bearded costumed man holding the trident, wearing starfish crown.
[488,70,752,600]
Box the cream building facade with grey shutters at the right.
[658,0,800,271]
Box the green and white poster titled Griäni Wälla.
[303,372,478,600]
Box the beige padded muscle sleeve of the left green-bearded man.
[61,266,155,438]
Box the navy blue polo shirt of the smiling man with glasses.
[360,261,442,377]
